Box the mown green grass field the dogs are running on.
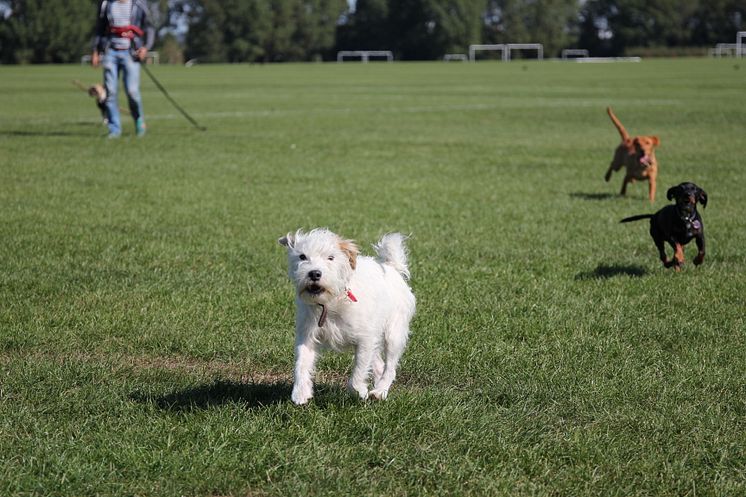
[0,59,746,497]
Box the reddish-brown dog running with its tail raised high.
[605,107,660,203]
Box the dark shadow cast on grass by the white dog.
[130,380,292,411]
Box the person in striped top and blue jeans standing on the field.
[91,0,155,138]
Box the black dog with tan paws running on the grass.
[620,183,707,271]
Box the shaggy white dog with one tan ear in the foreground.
[278,228,415,404]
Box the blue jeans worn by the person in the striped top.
[103,48,142,135]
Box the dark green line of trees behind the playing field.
[0,0,746,63]
